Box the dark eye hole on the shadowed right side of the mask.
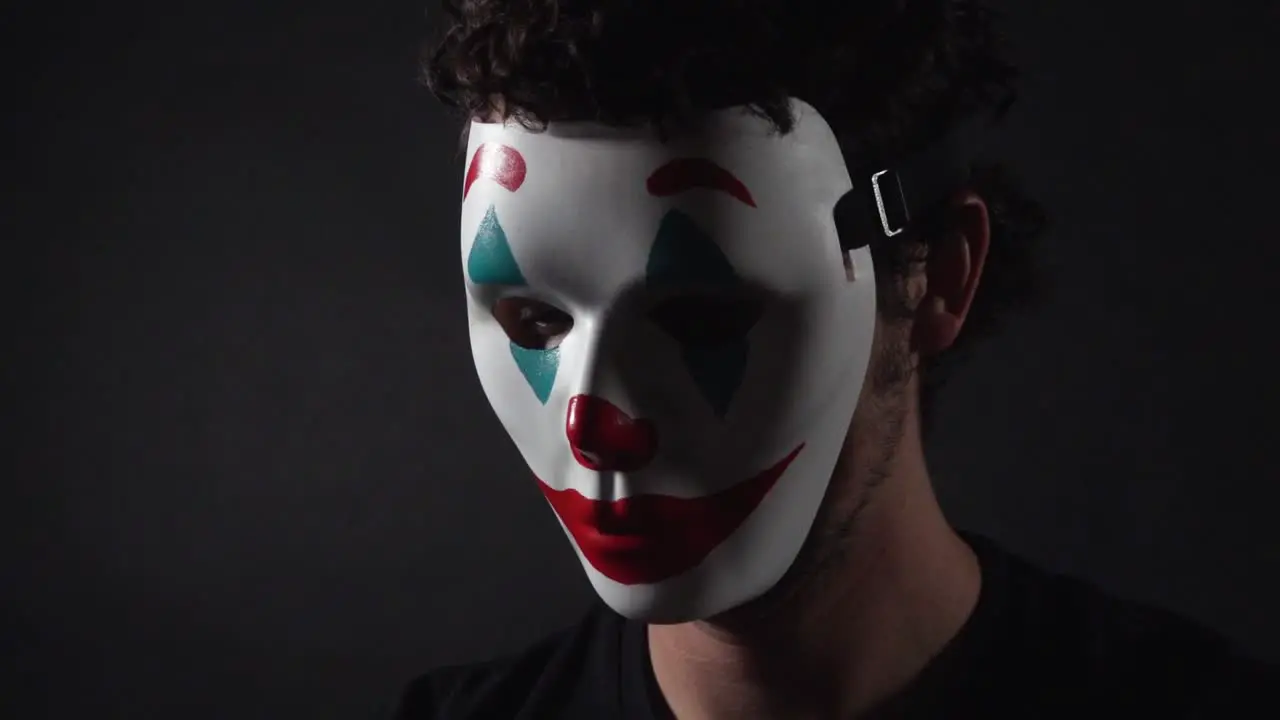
[649,292,763,345]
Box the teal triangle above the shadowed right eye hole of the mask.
[645,210,740,287]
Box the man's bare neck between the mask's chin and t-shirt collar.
[649,415,980,720]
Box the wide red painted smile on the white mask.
[538,443,804,585]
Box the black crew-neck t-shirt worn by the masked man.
[396,536,1280,720]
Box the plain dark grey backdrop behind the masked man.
[10,0,1280,720]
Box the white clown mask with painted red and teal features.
[462,101,876,623]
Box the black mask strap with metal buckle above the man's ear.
[833,95,1015,252]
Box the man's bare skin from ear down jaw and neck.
[649,193,991,720]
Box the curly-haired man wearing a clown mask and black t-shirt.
[399,0,1266,720]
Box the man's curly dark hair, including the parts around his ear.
[424,0,1044,427]
